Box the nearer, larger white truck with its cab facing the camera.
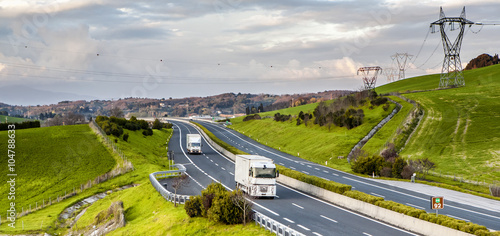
[234,155,279,198]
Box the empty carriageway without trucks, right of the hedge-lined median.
[196,120,500,231]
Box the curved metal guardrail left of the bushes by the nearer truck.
[149,164,191,204]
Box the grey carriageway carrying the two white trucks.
[169,120,416,236]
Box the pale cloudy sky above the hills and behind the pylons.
[0,0,500,105]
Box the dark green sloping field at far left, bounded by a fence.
[0,125,116,214]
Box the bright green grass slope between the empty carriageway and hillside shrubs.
[231,103,395,172]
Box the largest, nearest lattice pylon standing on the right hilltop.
[431,7,474,88]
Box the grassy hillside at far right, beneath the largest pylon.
[376,65,500,183]
